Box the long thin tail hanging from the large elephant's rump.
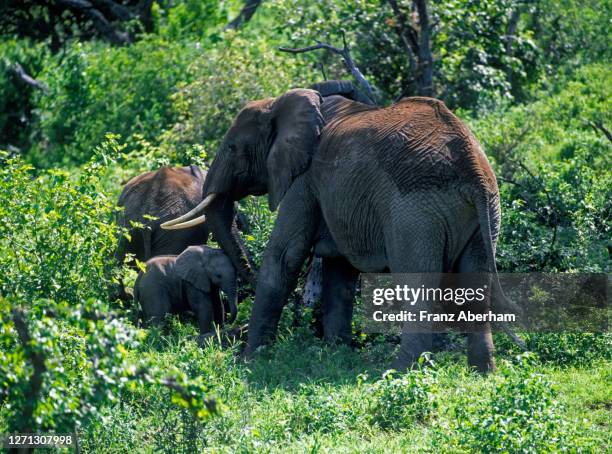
[476,190,527,350]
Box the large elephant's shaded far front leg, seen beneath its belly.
[321,257,359,344]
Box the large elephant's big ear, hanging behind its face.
[266,89,324,211]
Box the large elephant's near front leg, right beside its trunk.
[245,177,320,357]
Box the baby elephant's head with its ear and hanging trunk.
[175,246,238,323]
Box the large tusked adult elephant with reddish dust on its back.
[164,89,500,372]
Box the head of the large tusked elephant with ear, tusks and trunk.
[162,89,324,276]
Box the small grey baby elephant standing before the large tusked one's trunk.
[134,246,237,334]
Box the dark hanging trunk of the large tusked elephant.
[206,196,255,284]
